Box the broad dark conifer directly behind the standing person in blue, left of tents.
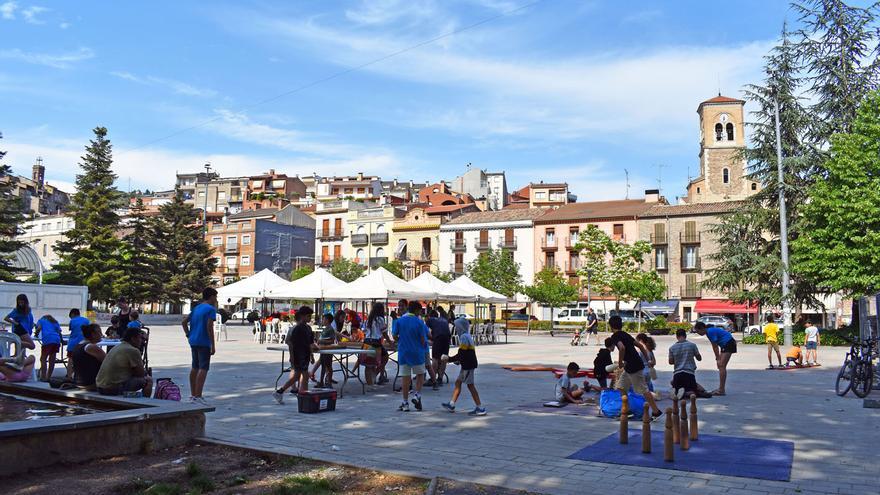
[153,190,216,305]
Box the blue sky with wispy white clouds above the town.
[0,0,808,201]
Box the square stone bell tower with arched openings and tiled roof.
[687,94,760,203]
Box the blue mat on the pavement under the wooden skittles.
[568,431,794,481]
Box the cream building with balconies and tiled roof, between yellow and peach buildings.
[440,208,546,302]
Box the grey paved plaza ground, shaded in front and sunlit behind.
[141,325,880,494]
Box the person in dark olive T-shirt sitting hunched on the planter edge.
[95,328,153,397]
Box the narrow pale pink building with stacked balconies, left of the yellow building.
[314,199,376,266]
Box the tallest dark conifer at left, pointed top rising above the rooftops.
[55,127,123,301]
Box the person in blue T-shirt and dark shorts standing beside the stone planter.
[182,287,217,404]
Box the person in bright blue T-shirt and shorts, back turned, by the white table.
[391,301,428,412]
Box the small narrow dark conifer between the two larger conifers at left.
[116,198,164,302]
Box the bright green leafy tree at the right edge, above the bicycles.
[792,91,880,296]
